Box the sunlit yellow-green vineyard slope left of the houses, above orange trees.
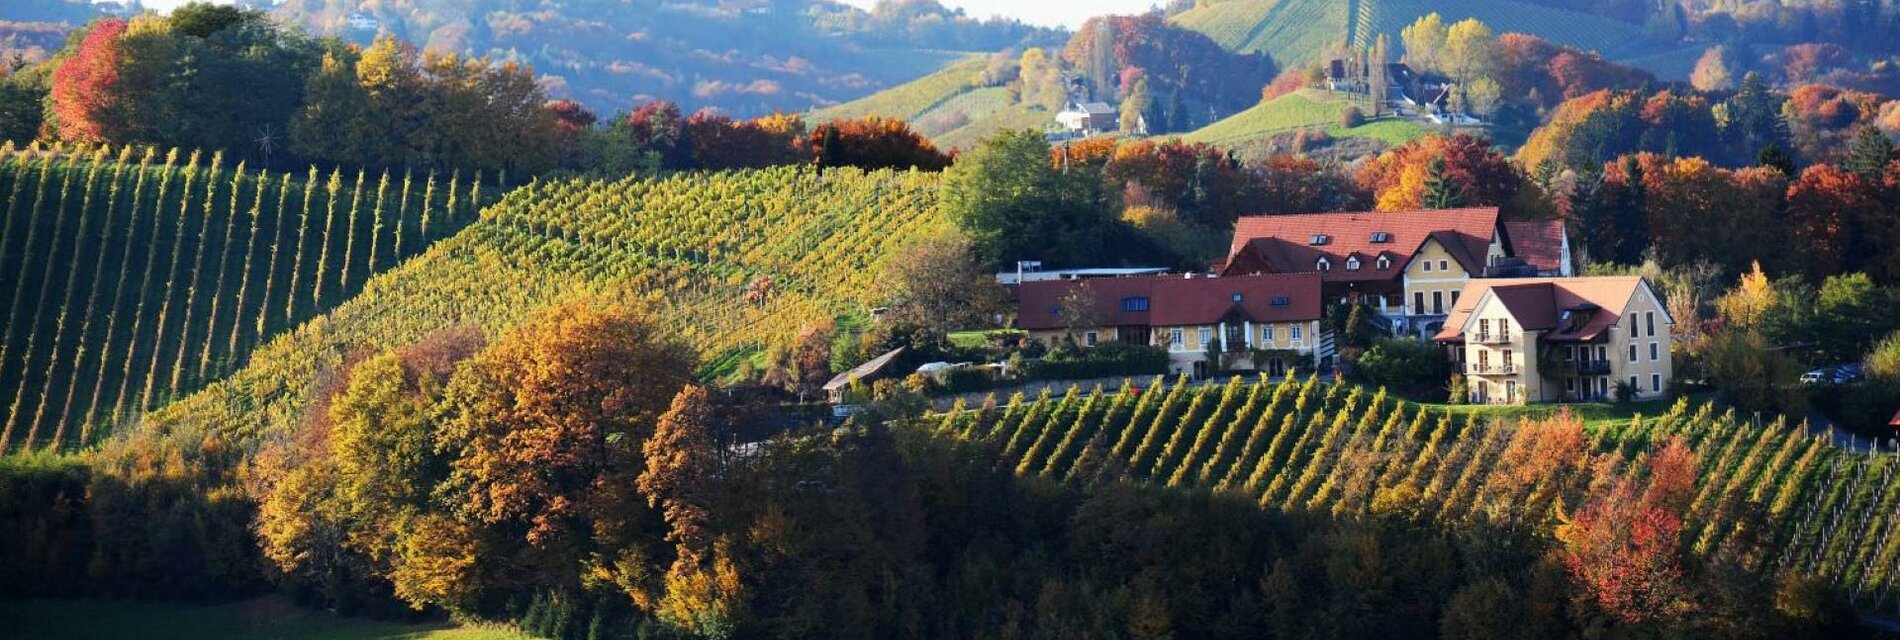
[152,167,946,446]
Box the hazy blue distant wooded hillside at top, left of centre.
[272,0,1062,116]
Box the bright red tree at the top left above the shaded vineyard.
[51,17,125,144]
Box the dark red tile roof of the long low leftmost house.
[1017,273,1322,330]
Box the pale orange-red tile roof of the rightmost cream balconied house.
[1436,275,1666,342]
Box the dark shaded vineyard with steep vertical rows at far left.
[0,146,483,450]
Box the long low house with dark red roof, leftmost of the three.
[1017,273,1332,376]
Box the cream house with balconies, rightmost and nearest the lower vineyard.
[1436,275,1676,405]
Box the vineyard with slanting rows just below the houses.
[923,378,1900,612]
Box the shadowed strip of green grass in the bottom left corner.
[0,598,528,640]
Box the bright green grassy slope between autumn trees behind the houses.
[1182,89,1427,146]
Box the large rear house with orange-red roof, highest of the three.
[1220,207,1573,336]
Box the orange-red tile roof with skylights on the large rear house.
[1224,207,1497,281]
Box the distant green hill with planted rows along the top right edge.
[1172,0,1674,77]
